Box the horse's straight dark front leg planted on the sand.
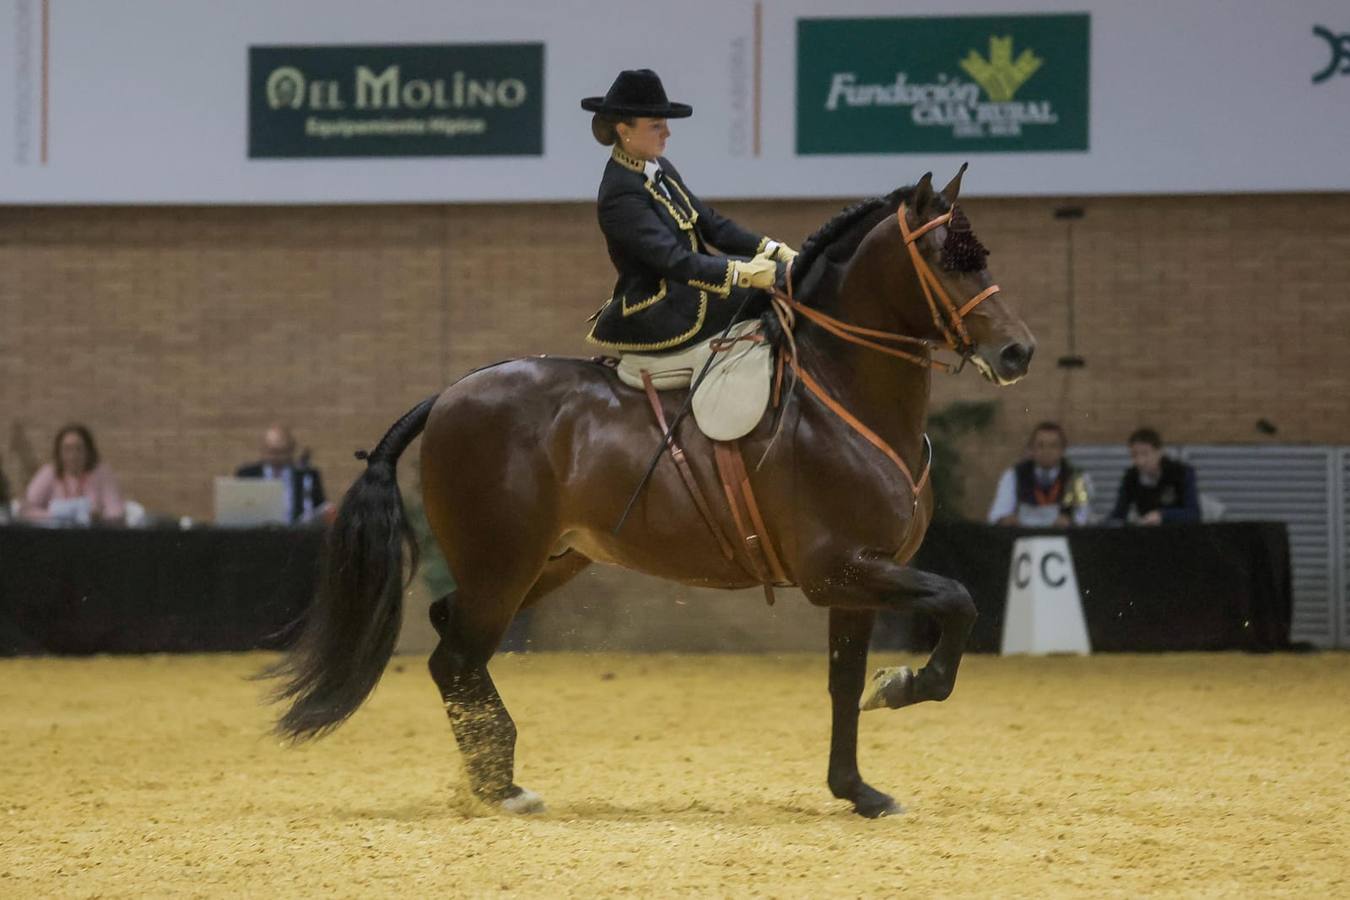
[828,609,903,819]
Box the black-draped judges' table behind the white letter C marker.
[913,522,1293,653]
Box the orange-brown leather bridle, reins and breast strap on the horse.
[771,204,999,507]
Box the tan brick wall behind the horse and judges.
[0,194,1350,517]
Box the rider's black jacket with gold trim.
[587,147,768,352]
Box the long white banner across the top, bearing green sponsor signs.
[0,0,1350,204]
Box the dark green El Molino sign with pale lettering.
[248,43,544,158]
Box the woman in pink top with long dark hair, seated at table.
[19,425,127,525]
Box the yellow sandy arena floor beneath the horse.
[0,653,1350,897]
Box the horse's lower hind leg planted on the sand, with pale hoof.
[428,588,543,812]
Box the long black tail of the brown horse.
[262,397,436,741]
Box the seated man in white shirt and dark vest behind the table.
[988,422,1092,528]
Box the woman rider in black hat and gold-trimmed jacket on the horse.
[582,69,797,354]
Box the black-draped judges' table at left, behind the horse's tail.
[0,525,323,656]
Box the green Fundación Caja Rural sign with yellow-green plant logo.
[797,13,1089,154]
